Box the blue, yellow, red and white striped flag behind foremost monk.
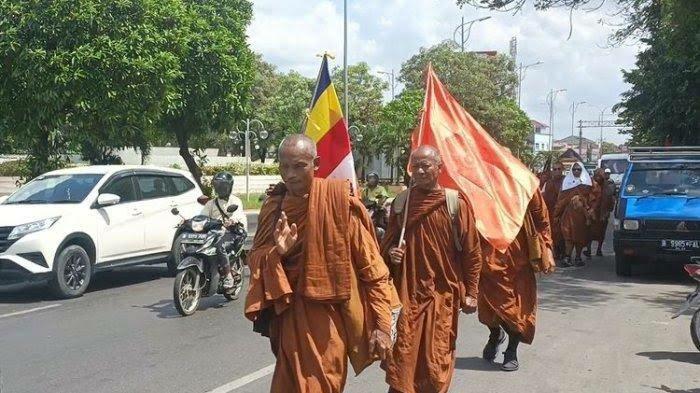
[304,55,357,185]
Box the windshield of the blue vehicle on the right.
[625,166,700,197]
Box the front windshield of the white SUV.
[5,174,103,205]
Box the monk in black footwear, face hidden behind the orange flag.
[479,190,554,371]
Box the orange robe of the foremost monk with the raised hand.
[245,179,393,393]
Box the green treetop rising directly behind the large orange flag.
[400,42,532,155]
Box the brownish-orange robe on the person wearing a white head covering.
[554,184,595,247]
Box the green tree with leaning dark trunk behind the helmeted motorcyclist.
[162,0,254,185]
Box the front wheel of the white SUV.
[50,245,92,299]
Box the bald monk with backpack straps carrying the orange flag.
[382,146,481,393]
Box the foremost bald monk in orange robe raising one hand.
[245,134,395,393]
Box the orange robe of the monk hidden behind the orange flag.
[479,191,552,344]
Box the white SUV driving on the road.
[0,165,202,298]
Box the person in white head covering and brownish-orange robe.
[554,162,594,267]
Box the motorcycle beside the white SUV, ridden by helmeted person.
[171,205,248,316]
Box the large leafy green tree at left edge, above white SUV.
[0,0,186,176]
